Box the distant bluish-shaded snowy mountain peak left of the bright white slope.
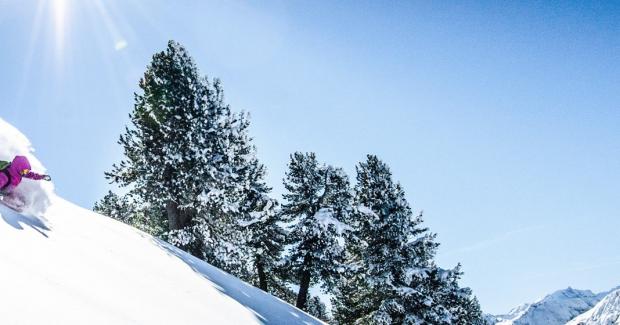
[496,287,603,325]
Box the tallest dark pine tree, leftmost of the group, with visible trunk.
[106,41,209,256]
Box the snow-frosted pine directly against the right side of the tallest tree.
[193,109,284,280]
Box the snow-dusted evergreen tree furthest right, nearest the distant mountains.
[334,155,478,324]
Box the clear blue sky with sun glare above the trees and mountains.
[0,0,620,313]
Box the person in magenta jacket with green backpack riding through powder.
[0,156,52,211]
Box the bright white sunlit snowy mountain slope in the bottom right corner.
[567,289,620,325]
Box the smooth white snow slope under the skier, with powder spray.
[0,119,321,324]
